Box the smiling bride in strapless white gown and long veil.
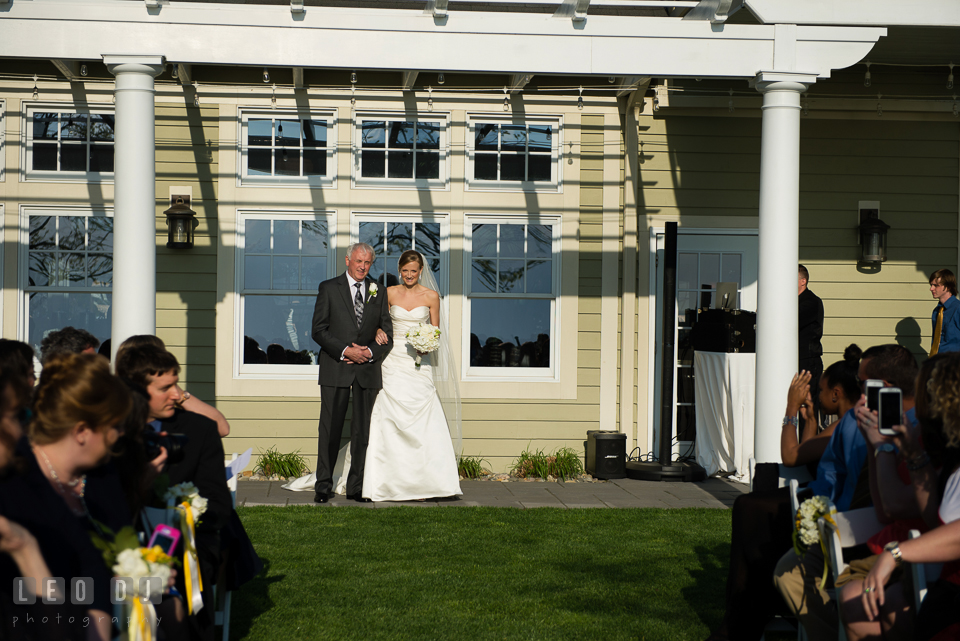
[284,250,462,501]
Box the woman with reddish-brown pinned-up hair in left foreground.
[0,354,130,640]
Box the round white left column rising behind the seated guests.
[103,55,164,353]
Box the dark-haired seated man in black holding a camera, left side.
[116,345,233,638]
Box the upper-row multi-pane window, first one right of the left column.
[240,112,336,184]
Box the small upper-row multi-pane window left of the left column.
[27,108,115,177]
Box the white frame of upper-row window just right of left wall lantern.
[236,106,340,189]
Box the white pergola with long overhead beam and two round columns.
[0,0,944,462]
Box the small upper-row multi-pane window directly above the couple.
[357,117,447,186]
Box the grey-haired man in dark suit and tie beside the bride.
[312,243,393,503]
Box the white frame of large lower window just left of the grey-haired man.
[231,208,336,381]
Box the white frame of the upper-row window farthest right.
[463,111,573,194]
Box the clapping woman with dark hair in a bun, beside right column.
[708,345,862,641]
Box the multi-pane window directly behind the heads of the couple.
[358,219,446,294]
